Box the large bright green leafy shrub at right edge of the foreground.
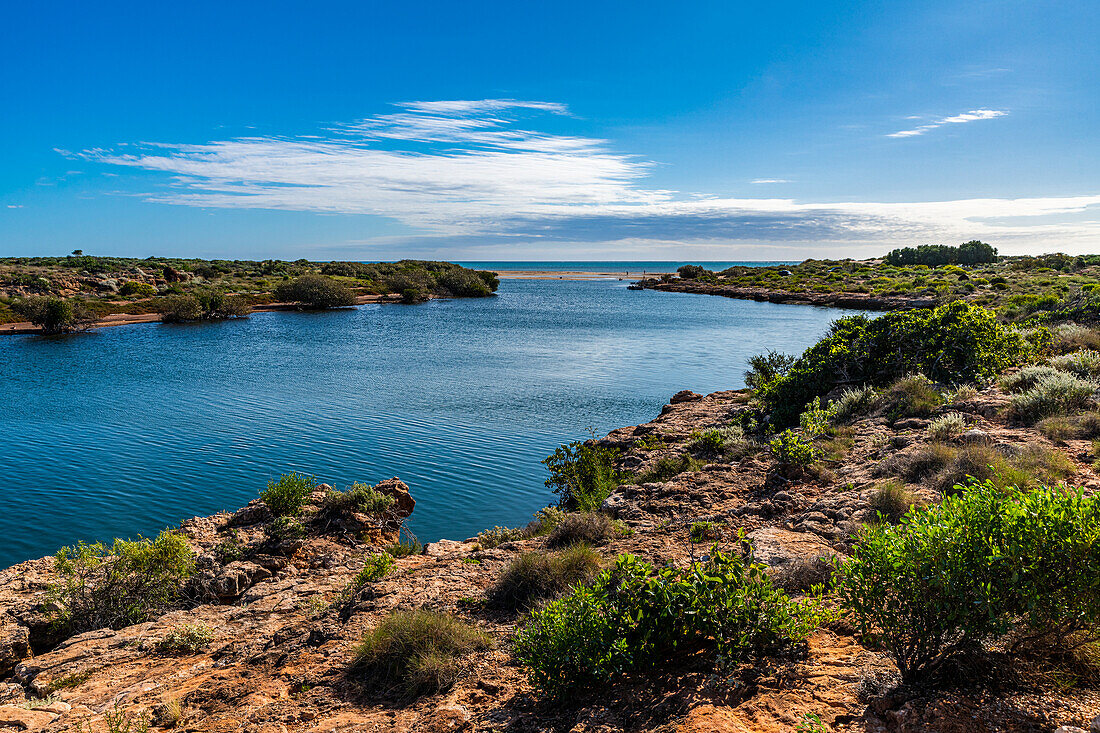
[838,482,1100,683]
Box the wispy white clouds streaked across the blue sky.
[74,100,1100,249]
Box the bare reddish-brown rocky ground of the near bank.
[0,378,1100,733]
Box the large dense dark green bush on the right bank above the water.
[759,302,1027,426]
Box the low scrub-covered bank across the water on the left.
[0,253,498,325]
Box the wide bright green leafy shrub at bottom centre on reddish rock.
[514,549,823,696]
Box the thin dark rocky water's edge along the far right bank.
[630,277,935,310]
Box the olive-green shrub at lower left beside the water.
[48,532,195,634]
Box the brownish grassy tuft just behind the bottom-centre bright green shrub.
[487,544,600,611]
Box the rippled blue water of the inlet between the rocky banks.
[0,281,853,566]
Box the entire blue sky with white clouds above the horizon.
[0,0,1100,260]
